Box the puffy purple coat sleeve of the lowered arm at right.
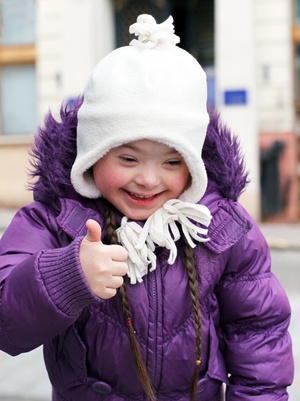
[216,217,293,401]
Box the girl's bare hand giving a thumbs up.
[79,220,128,299]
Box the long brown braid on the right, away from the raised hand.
[184,238,202,401]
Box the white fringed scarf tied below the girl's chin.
[117,199,211,284]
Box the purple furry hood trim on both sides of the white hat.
[30,97,248,202]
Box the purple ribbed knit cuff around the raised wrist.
[38,237,99,316]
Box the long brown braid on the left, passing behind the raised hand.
[104,202,155,401]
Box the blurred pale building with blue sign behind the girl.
[0,0,300,222]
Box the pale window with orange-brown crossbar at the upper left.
[0,0,37,135]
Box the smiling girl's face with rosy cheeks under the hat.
[93,139,189,220]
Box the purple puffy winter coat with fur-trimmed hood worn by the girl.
[0,102,293,401]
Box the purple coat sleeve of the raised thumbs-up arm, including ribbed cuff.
[0,202,99,355]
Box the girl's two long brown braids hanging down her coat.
[103,201,202,401]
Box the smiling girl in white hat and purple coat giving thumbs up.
[0,15,293,401]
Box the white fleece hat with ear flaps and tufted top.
[71,14,209,203]
